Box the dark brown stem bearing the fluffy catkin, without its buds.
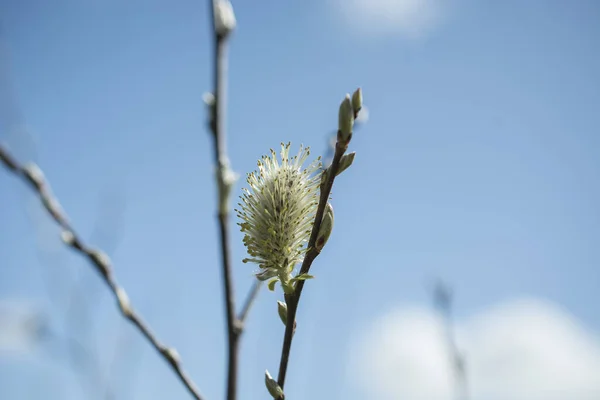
[277,133,349,394]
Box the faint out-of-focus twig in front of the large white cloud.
[433,281,469,400]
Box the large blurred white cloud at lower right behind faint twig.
[349,299,600,400]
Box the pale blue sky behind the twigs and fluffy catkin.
[0,0,600,400]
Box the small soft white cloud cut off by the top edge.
[332,0,447,39]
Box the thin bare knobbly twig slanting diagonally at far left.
[0,144,203,400]
